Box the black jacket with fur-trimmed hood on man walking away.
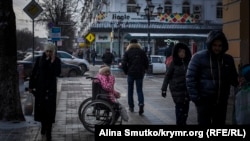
[122,43,149,79]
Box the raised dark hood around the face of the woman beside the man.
[172,43,192,64]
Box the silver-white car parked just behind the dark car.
[29,50,89,74]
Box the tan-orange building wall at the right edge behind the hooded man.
[223,0,250,69]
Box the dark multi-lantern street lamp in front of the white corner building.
[135,0,163,65]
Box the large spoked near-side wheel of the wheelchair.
[81,100,115,133]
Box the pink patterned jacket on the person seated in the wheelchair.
[96,73,119,102]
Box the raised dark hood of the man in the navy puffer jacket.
[206,30,228,54]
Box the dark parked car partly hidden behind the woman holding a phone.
[17,55,83,79]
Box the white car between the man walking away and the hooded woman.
[150,55,166,74]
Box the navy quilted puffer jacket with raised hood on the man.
[186,31,238,105]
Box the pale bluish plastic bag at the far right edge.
[235,84,250,125]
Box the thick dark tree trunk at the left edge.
[0,0,25,121]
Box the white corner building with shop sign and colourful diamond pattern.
[80,0,223,58]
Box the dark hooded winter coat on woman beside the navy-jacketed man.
[161,43,191,104]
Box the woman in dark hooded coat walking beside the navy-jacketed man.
[161,43,192,125]
